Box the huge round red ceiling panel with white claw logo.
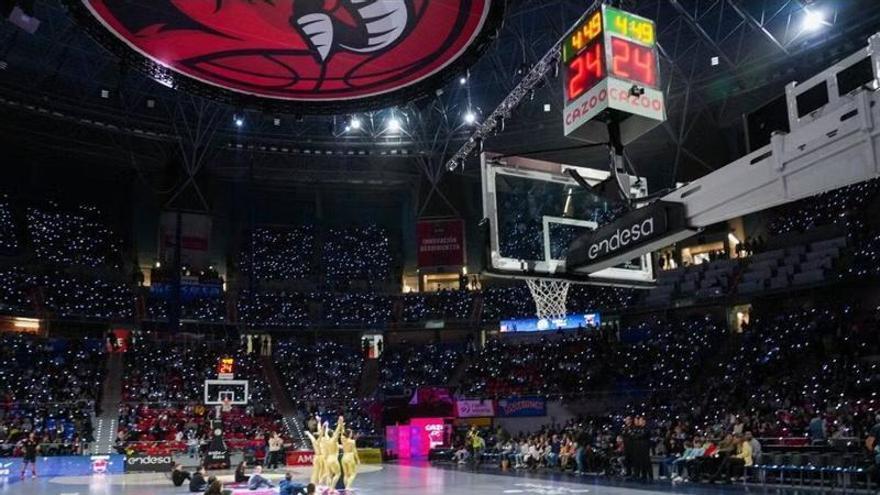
[69,0,503,113]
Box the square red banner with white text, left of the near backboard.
[416,218,465,268]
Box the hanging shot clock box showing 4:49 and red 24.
[560,5,666,143]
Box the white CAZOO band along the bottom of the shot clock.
[563,78,666,136]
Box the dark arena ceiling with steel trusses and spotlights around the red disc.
[0,0,880,198]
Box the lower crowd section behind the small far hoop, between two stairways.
[117,341,283,454]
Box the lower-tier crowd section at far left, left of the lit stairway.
[0,334,104,456]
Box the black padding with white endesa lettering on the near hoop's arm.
[566,201,685,269]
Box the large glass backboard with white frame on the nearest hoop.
[480,153,654,285]
